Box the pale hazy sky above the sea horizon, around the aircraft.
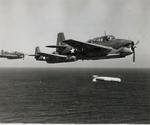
[0,0,150,68]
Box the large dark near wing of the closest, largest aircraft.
[63,39,112,52]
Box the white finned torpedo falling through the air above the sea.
[92,75,121,82]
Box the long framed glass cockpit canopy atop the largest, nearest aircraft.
[87,35,115,43]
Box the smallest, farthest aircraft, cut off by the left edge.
[0,50,25,59]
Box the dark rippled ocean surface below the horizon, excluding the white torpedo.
[0,68,150,123]
